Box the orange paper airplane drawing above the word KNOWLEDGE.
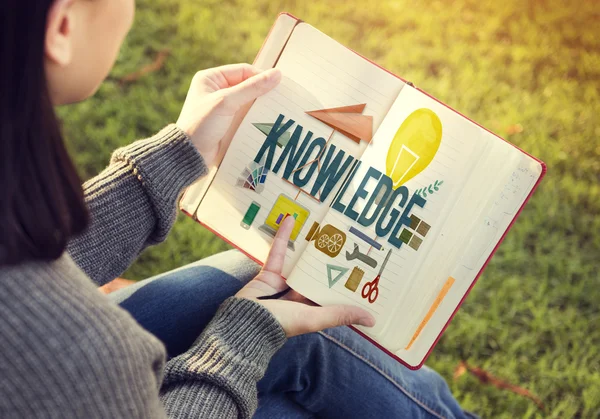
[306,103,373,143]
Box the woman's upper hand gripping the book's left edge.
[176,64,281,165]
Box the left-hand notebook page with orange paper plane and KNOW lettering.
[197,23,404,276]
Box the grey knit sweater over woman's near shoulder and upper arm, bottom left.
[0,255,165,417]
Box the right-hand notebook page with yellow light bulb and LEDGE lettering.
[288,86,542,366]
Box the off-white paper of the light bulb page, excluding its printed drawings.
[288,87,541,366]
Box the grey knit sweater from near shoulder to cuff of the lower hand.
[0,256,285,419]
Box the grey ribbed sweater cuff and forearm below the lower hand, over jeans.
[161,297,286,418]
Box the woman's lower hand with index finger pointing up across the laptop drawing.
[236,217,375,337]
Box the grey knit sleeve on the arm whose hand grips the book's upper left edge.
[68,125,208,285]
